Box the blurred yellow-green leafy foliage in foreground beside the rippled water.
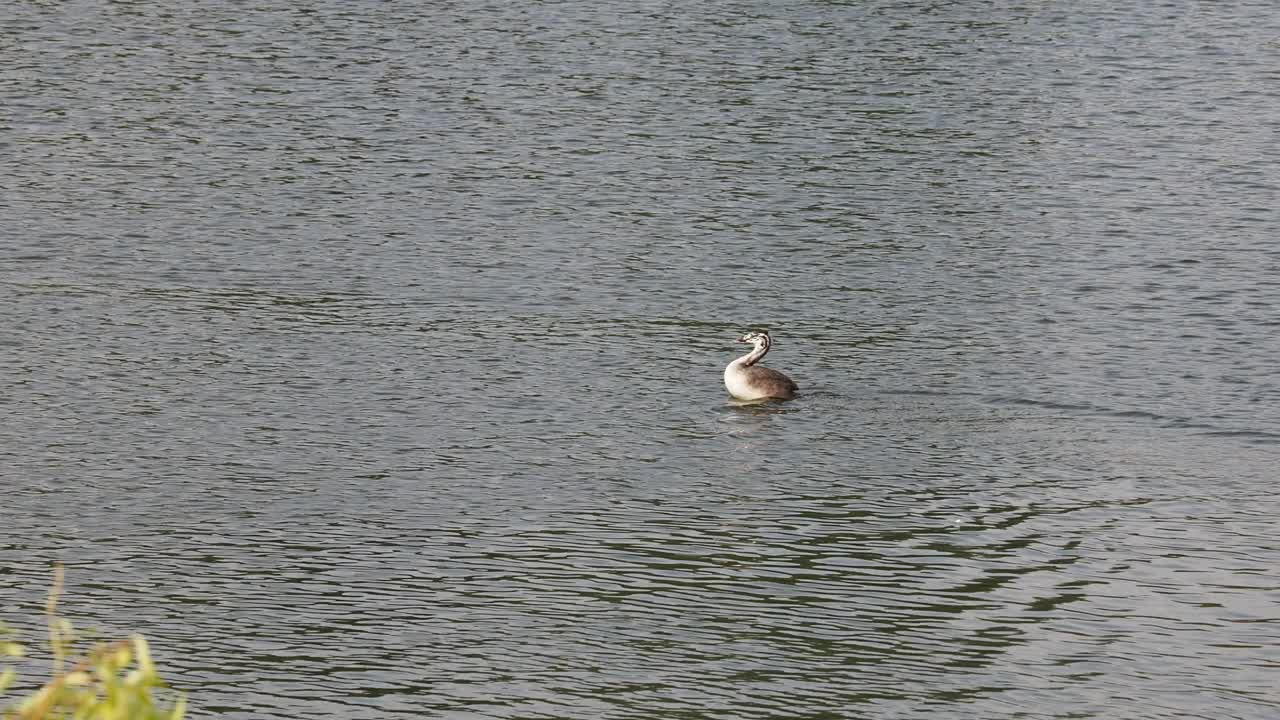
[0,565,186,720]
